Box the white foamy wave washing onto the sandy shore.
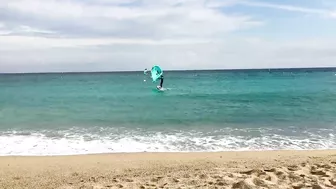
[0,129,336,156]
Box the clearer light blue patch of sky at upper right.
[228,0,336,40]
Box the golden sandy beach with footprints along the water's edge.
[0,150,336,189]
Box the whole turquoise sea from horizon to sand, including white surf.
[0,69,336,156]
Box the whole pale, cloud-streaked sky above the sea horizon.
[0,0,336,72]
